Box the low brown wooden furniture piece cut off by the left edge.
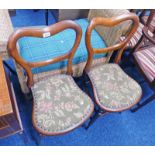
[0,57,23,138]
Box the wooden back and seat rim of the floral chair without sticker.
[84,13,140,113]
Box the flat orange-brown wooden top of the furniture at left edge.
[0,58,13,116]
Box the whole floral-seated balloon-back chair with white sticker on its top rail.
[8,20,94,135]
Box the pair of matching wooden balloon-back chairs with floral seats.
[8,14,142,135]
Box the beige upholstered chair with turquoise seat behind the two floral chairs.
[16,9,131,94]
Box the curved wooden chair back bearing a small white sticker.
[8,20,82,87]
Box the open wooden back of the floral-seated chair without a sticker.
[85,13,139,72]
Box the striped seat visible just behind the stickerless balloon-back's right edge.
[120,23,144,49]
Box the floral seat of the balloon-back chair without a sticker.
[88,63,142,112]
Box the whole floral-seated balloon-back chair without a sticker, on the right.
[83,14,142,128]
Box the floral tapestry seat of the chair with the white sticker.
[32,74,94,135]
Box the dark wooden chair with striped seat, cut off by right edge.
[132,26,155,112]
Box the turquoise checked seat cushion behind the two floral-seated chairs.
[18,19,106,74]
